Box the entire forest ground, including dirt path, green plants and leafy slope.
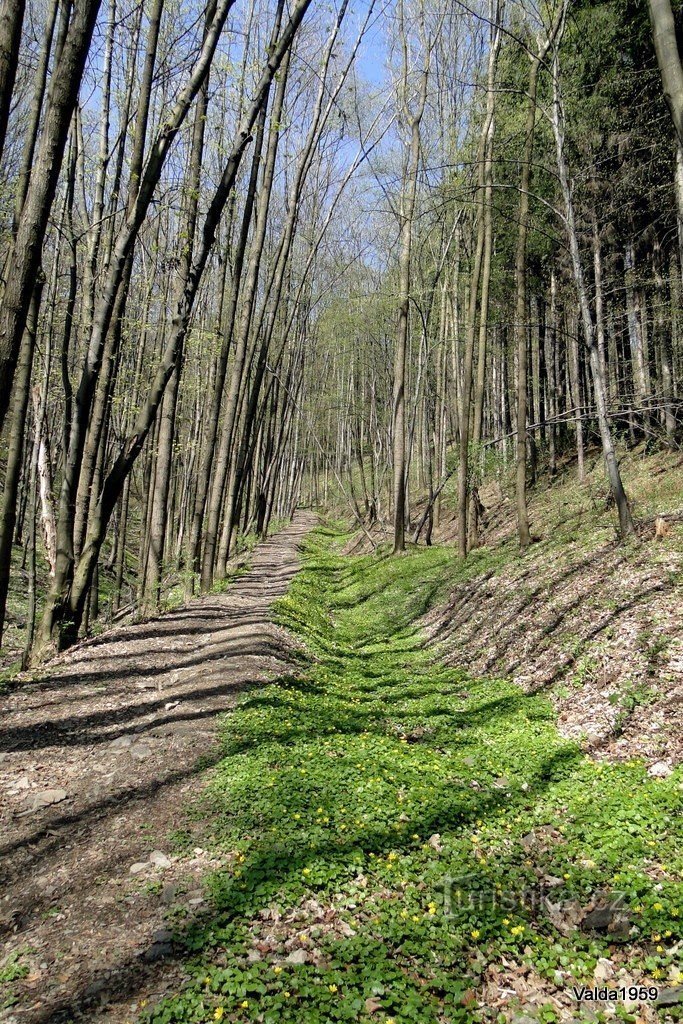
[0,454,683,1024]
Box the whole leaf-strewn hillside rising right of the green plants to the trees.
[354,449,683,773]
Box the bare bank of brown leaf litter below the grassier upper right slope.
[425,524,683,776]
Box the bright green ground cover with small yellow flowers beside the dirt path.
[145,529,683,1024]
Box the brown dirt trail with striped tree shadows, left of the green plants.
[0,514,314,1024]
